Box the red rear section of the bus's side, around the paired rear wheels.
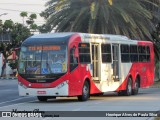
[116,44,154,91]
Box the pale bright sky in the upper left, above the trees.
[0,0,48,25]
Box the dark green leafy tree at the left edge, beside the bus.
[0,20,31,76]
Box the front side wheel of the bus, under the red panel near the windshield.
[78,81,90,101]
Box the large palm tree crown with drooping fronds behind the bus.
[41,0,160,39]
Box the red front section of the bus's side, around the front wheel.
[68,34,100,96]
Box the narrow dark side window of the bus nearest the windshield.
[70,47,78,72]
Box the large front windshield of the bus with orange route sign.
[18,45,67,74]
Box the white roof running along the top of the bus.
[30,32,149,44]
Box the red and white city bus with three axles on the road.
[18,32,154,101]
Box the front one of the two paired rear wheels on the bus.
[124,77,132,96]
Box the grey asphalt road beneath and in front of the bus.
[0,80,160,120]
